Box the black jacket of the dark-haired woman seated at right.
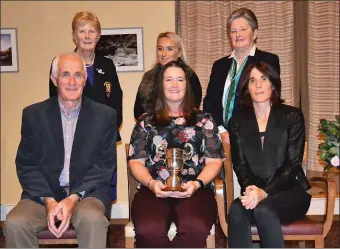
[228,104,310,194]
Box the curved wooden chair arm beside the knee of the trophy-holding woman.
[214,178,228,236]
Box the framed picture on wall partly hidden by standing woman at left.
[96,27,144,72]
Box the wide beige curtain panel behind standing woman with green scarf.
[176,1,299,105]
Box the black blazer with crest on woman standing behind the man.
[49,55,123,141]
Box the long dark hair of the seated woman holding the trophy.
[151,60,195,126]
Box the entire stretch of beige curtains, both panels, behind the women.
[176,1,340,170]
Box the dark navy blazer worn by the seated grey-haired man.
[16,97,117,213]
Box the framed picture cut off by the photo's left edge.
[0,28,19,72]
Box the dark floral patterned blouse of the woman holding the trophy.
[128,110,224,188]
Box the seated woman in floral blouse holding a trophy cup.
[128,61,224,248]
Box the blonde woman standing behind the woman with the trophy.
[134,32,202,119]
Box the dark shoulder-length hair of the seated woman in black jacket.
[239,61,284,108]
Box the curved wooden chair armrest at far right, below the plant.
[308,177,336,237]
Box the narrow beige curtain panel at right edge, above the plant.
[308,1,340,170]
